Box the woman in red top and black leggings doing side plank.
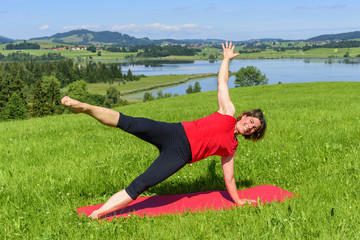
[61,42,266,219]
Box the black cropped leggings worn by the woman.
[117,113,191,200]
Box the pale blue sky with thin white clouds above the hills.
[0,0,360,41]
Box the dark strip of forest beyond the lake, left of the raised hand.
[137,45,201,57]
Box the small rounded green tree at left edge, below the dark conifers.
[1,93,27,120]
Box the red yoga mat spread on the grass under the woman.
[76,185,296,220]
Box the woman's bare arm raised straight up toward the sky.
[218,42,239,116]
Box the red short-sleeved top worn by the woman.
[182,112,238,163]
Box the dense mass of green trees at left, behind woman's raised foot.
[0,60,139,120]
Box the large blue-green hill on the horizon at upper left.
[30,29,153,46]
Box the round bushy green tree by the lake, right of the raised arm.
[235,66,269,87]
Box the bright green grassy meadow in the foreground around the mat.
[0,82,360,239]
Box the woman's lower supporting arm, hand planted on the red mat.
[221,153,256,206]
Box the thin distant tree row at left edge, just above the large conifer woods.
[0,52,65,62]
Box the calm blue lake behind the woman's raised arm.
[121,59,360,98]
